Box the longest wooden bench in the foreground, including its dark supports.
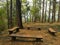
[9,34,43,42]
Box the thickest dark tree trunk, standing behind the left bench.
[16,0,23,29]
